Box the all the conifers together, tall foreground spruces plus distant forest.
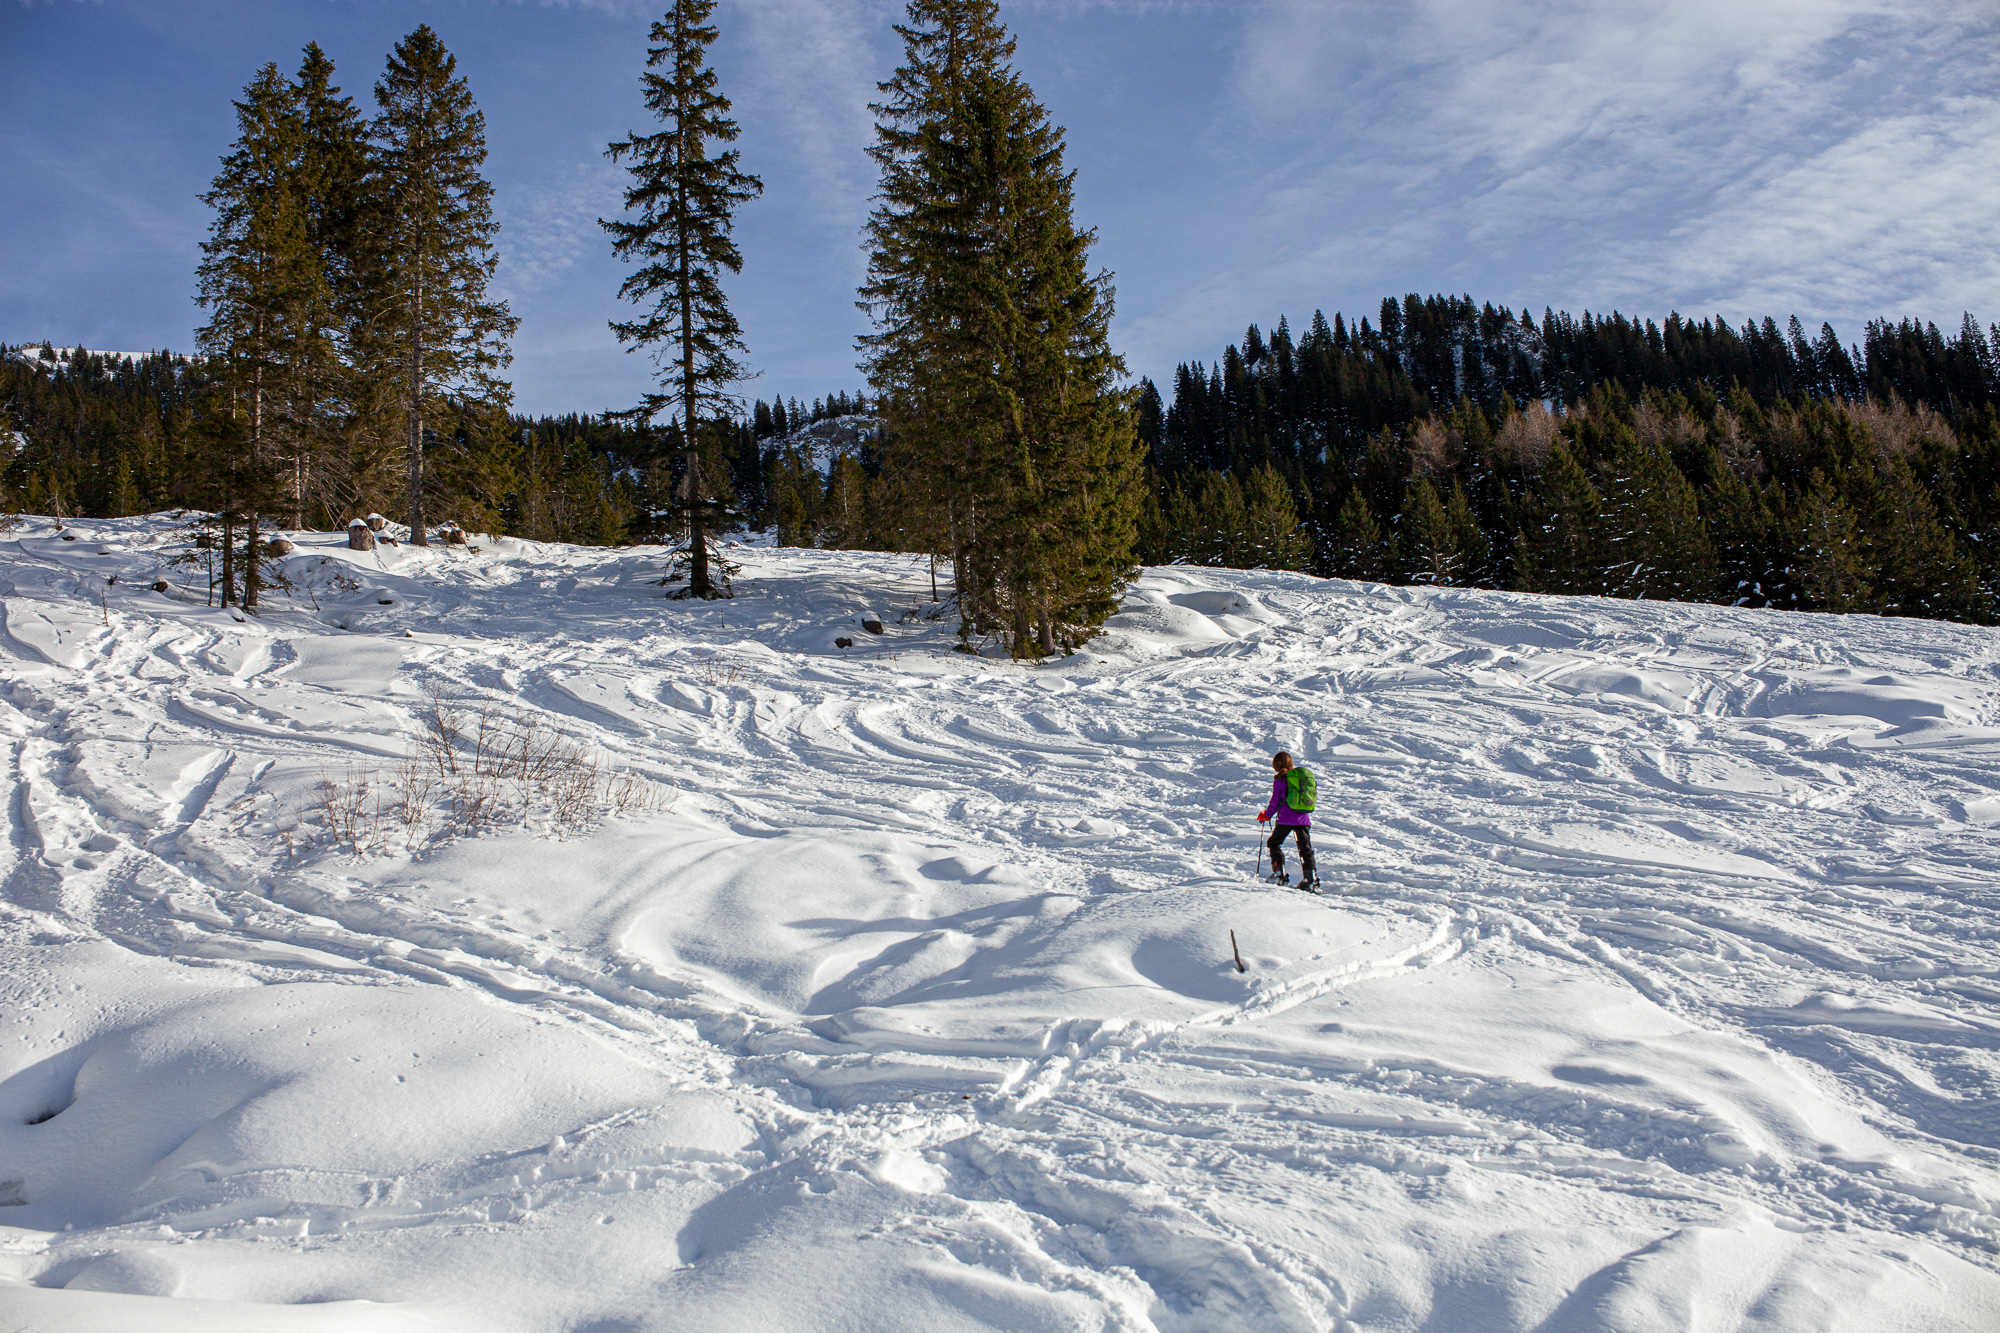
[0,0,2000,640]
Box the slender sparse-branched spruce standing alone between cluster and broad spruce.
[600,0,764,598]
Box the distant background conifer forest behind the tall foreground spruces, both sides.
[0,296,2000,622]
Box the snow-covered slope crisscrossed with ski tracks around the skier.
[0,518,2000,1333]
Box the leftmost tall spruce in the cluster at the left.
[198,64,332,608]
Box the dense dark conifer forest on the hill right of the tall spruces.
[1138,296,2000,622]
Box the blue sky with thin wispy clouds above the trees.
[0,0,2000,412]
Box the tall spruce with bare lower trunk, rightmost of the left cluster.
[360,24,520,546]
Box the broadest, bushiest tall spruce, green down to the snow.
[860,0,1140,656]
